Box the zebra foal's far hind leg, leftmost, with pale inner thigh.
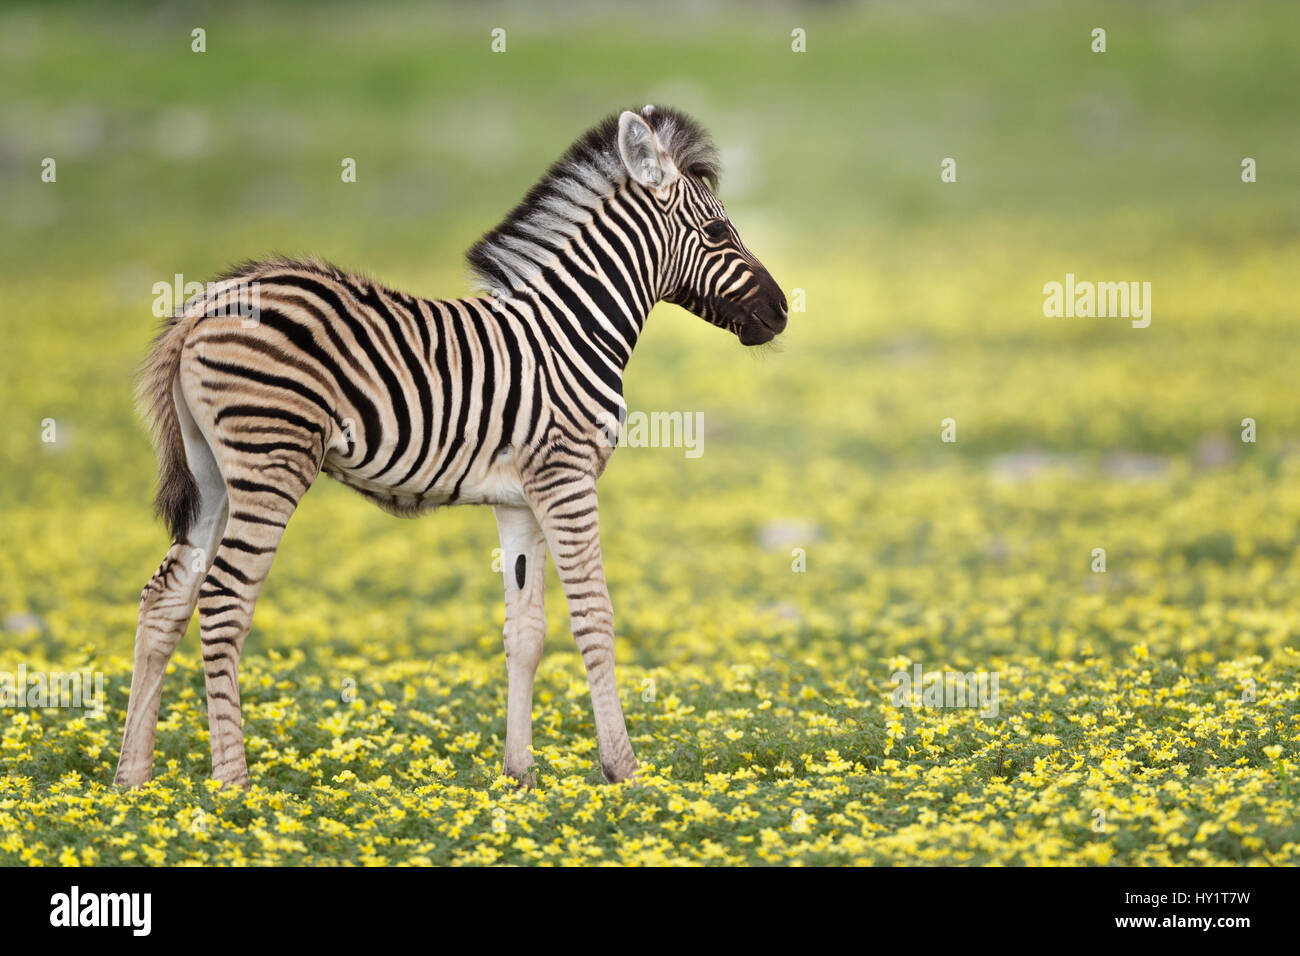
[113,415,226,787]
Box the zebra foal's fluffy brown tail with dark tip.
[137,312,199,541]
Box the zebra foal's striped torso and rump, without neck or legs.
[178,260,545,515]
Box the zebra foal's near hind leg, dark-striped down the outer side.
[199,444,320,787]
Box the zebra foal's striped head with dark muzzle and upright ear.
[618,107,788,345]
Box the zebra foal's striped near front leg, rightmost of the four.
[534,475,637,783]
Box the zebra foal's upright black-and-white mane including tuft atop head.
[465,107,722,294]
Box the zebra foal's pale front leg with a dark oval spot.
[493,505,546,787]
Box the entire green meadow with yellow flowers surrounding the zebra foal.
[0,3,1300,866]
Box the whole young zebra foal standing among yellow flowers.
[114,105,788,788]
